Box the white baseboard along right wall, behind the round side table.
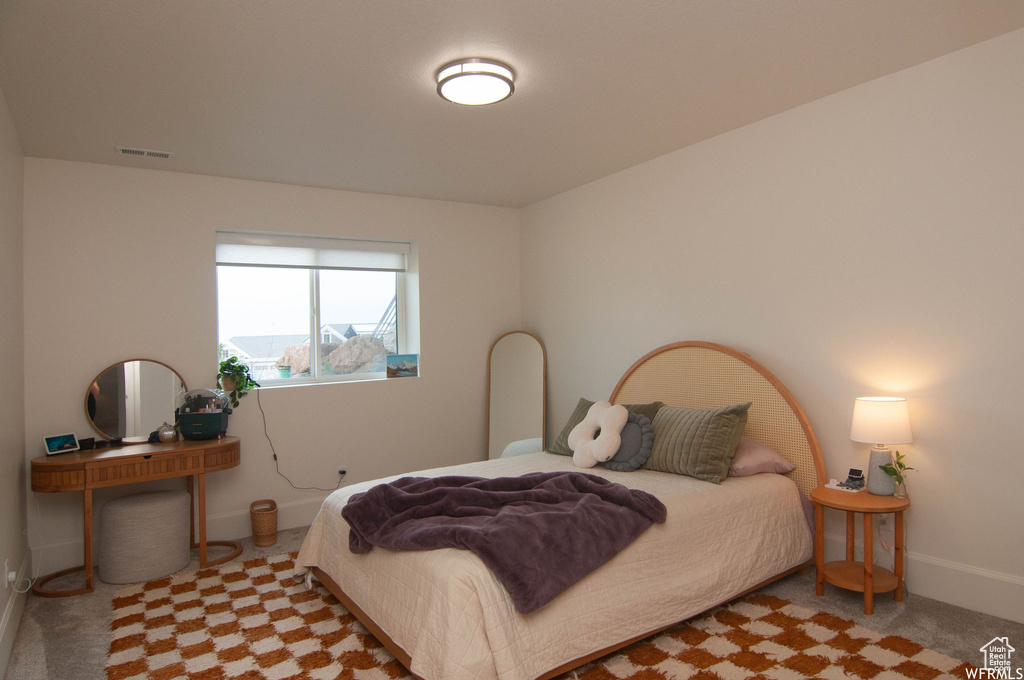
[825,534,1024,624]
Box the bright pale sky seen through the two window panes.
[217,266,396,341]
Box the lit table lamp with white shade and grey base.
[850,396,913,496]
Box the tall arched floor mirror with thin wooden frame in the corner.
[487,331,548,459]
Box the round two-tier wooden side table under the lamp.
[811,486,910,614]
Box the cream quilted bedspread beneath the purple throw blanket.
[296,453,812,680]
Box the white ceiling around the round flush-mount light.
[0,0,1024,207]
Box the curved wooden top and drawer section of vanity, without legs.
[32,436,242,494]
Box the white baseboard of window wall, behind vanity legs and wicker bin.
[32,494,328,573]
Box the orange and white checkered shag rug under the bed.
[106,553,968,680]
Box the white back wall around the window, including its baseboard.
[24,159,520,572]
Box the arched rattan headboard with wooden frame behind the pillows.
[609,341,825,495]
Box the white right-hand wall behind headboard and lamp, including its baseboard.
[522,26,1024,621]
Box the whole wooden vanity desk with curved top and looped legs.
[32,436,242,597]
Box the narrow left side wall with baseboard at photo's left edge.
[0,85,28,677]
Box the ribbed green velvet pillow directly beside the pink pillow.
[644,401,751,484]
